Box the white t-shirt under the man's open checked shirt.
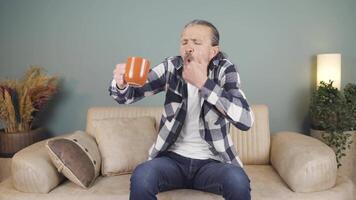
[169,83,216,159]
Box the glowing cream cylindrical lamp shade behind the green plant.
[317,53,341,90]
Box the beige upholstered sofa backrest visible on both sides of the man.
[86,105,270,165]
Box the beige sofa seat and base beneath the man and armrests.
[0,165,355,200]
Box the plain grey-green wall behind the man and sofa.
[0,0,356,135]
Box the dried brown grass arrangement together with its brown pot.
[0,66,58,157]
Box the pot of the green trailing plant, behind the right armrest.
[310,129,356,185]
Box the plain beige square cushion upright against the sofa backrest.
[92,117,157,176]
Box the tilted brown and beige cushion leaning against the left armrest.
[46,131,101,188]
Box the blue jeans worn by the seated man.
[130,152,251,200]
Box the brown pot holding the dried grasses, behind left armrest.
[0,128,46,157]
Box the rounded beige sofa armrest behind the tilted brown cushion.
[11,133,80,193]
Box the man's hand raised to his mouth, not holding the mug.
[183,59,208,89]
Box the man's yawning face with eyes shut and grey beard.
[179,25,219,63]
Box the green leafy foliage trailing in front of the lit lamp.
[310,81,353,168]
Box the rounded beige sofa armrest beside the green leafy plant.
[271,132,337,192]
